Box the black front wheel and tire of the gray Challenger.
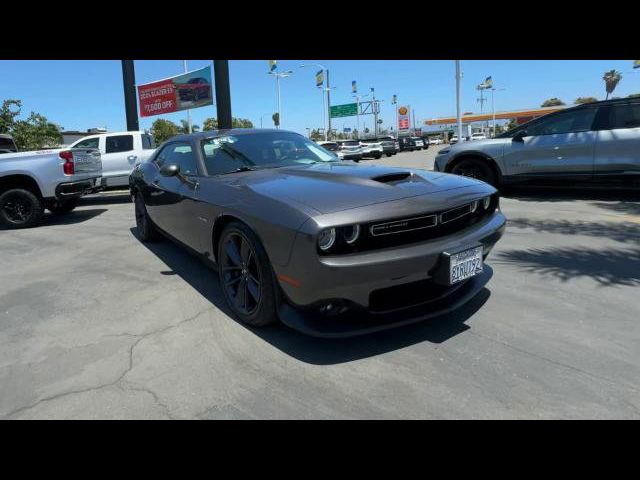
[218,222,278,327]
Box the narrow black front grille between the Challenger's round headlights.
[319,194,499,255]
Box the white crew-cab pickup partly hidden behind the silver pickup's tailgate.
[69,131,155,187]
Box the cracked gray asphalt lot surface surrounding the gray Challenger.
[0,147,640,419]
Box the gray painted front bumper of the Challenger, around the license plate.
[276,211,506,310]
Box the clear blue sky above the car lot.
[0,60,640,134]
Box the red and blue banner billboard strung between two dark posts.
[138,66,213,117]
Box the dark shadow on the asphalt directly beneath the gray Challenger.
[130,227,491,365]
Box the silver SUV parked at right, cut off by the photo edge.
[434,98,640,186]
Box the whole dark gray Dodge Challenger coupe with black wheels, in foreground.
[130,129,506,337]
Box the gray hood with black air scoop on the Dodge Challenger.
[236,162,482,214]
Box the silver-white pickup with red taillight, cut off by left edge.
[0,148,102,228]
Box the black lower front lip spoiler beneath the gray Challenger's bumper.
[278,264,493,338]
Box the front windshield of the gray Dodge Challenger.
[202,132,340,175]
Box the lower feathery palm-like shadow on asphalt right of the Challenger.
[494,248,640,287]
